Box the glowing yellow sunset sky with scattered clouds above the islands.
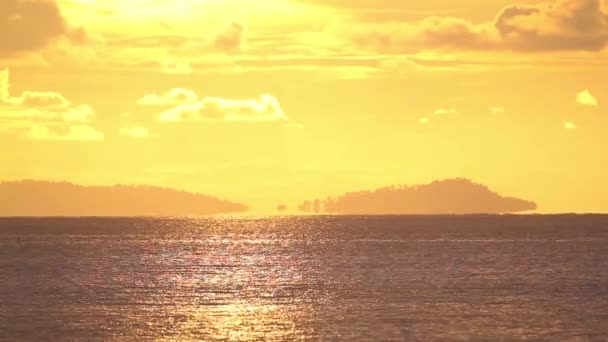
[0,0,608,213]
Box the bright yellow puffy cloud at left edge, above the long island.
[0,69,104,140]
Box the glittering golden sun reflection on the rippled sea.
[150,221,314,341]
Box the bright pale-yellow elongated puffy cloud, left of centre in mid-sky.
[138,88,287,122]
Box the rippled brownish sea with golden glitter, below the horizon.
[0,216,608,341]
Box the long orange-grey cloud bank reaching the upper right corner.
[340,0,608,52]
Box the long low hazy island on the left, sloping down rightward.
[0,180,248,216]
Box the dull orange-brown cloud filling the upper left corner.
[0,0,86,58]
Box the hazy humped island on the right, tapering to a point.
[299,178,537,215]
